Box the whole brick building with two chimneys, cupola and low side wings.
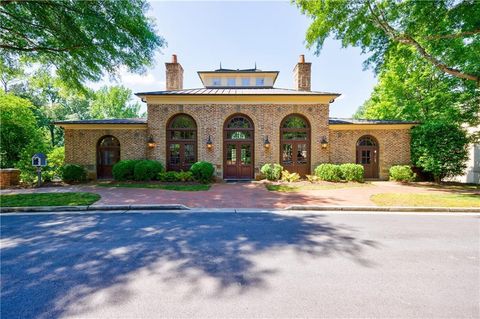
[56,55,414,179]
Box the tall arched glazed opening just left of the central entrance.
[167,114,197,171]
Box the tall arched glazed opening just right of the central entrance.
[280,114,310,176]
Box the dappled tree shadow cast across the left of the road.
[1,213,376,318]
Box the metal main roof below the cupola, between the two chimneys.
[135,87,340,96]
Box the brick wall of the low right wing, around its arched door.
[329,129,410,179]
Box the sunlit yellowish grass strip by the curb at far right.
[370,194,480,207]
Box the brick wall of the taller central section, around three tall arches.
[148,104,328,177]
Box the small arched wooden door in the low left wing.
[97,135,120,179]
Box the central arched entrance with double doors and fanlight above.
[223,114,254,179]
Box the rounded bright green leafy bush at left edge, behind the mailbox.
[0,92,44,168]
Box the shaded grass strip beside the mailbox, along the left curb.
[0,192,100,207]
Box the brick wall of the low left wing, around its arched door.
[65,129,147,179]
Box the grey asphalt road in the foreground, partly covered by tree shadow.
[1,212,480,319]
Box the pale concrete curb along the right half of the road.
[285,205,480,213]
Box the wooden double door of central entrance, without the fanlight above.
[224,141,253,179]
